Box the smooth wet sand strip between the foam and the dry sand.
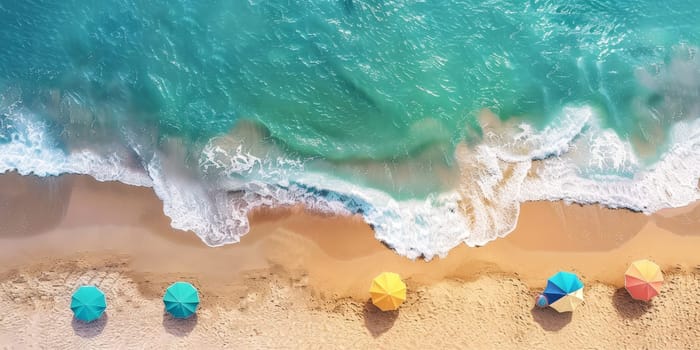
[0,174,700,292]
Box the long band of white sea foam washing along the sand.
[0,102,700,259]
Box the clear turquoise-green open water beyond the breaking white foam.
[0,0,700,159]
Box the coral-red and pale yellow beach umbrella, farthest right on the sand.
[625,260,664,301]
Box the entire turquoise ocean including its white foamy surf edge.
[0,0,700,259]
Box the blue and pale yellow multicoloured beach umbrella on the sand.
[542,271,583,312]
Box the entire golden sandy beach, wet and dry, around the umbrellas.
[0,174,700,349]
